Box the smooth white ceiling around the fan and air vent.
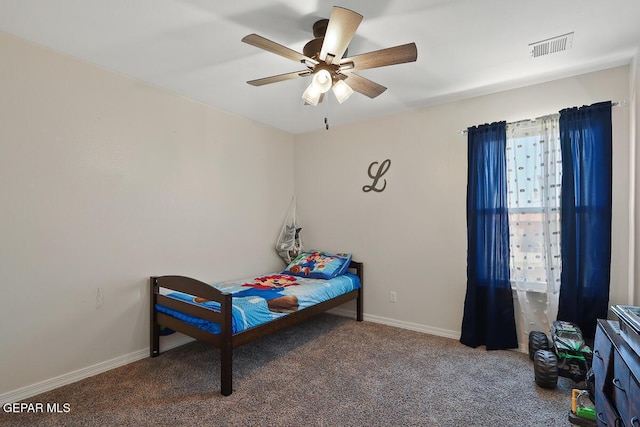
[0,0,640,134]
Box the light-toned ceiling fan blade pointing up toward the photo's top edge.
[320,6,362,64]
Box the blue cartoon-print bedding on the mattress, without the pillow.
[156,273,360,334]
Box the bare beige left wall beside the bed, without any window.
[0,33,293,400]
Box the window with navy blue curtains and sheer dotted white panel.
[460,101,613,348]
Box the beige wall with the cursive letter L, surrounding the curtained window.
[295,66,630,338]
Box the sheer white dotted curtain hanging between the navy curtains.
[507,114,562,342]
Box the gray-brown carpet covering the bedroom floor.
[0,314,575,426]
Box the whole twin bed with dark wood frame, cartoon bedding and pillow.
[150,251,363,396]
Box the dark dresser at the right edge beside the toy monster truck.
[593,320,640,427]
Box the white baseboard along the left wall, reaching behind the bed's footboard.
[0,333,193,406]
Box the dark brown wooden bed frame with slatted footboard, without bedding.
[150,261,364,396]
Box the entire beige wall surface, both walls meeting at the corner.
[0,28,640,401]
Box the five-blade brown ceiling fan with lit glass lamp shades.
[242,6,418,105]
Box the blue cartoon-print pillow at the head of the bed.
[283,251,351,279]
